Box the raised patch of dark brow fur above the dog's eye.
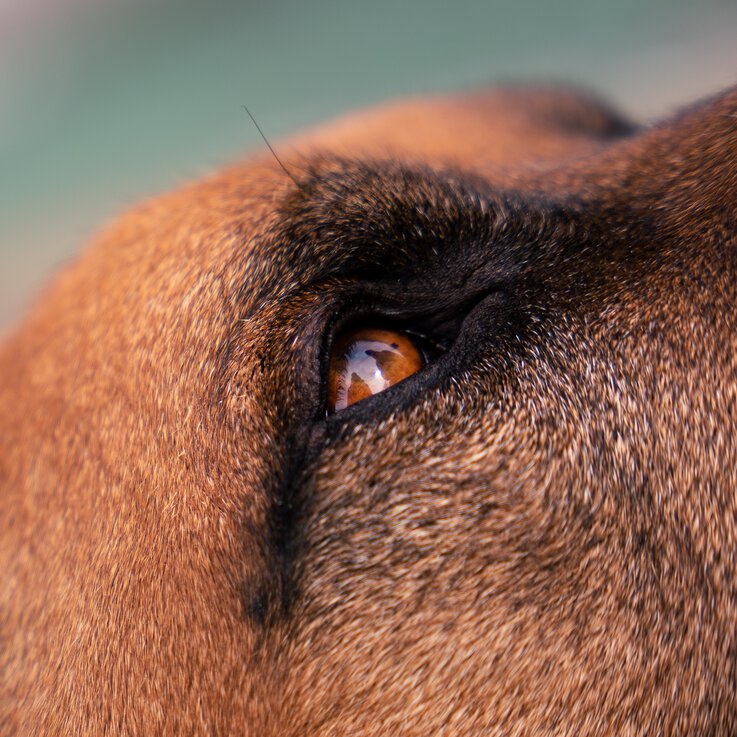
[269,162,547,287]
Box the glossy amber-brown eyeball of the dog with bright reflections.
[328,328,425,414]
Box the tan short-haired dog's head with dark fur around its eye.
[0,87,737,737]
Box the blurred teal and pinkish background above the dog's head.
[0,0,737,331]
